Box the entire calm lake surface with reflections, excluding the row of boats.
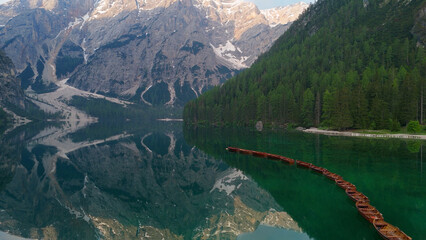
[0,122,426,240]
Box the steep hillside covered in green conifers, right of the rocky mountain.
[184,0,426,129]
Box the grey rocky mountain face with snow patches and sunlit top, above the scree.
[0,0,308,105]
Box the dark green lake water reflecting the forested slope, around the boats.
[185,128,426,239]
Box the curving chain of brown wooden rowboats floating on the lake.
[226,147,411,240]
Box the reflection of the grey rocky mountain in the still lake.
[0,122,308,239]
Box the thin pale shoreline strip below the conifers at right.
[301,128,426,140]
